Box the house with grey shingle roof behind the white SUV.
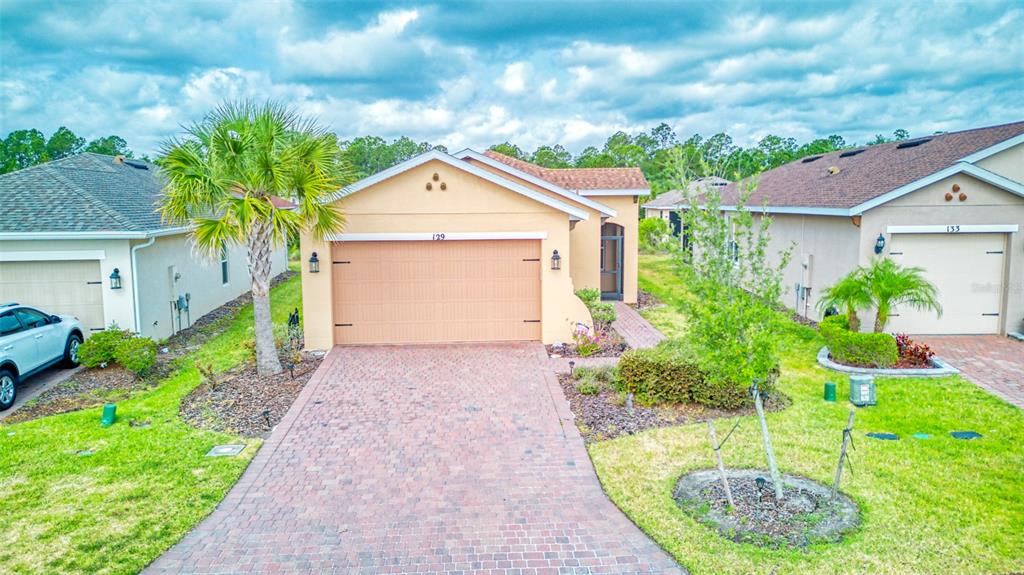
[0,153,288,340]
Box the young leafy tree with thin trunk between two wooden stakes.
[678,153,792,500]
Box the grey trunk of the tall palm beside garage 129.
[246,216,282,375]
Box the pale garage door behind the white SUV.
[0,260,103,337]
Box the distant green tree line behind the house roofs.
[0,123,910,194]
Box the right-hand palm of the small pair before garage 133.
[864,258,942,333]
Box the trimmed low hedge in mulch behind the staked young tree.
[618,342,750,409]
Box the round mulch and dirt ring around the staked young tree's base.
[673,470,860,547]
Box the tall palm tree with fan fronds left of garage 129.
[158,100,351,374]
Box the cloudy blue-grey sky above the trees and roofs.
[0,0,1024,152]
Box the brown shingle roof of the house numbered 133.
[722,122,1024,209]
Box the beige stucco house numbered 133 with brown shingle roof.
[644,122,1024,334]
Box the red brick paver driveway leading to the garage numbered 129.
[146,344,682,574]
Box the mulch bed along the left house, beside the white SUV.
[3,271,295,424]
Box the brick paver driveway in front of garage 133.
[913,336,1024,409]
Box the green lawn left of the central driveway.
[0,276,301,573]
